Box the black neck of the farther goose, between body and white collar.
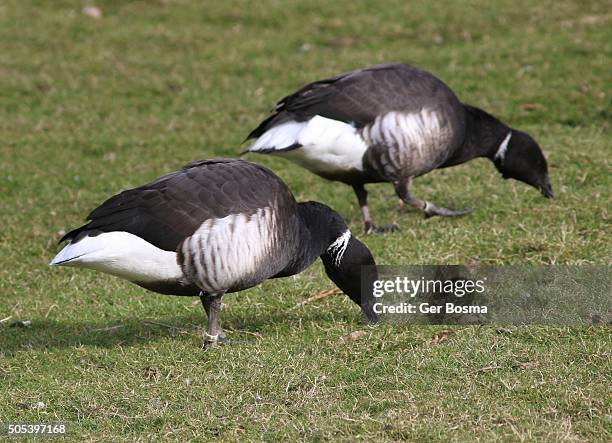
[443,105,511,167]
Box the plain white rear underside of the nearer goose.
[49,231,183,283]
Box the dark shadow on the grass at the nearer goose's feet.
[0,311,338,356]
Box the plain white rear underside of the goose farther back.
[249,115,368,174]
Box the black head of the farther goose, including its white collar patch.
[493,129,554,198]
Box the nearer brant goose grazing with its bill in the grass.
[50,159,377,344]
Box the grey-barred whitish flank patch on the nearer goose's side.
[181,208,277,293]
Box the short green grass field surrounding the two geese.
[0,0,612,441]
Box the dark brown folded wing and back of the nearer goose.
[60,160,295,251]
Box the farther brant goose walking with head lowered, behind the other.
[246,64,553,233]
